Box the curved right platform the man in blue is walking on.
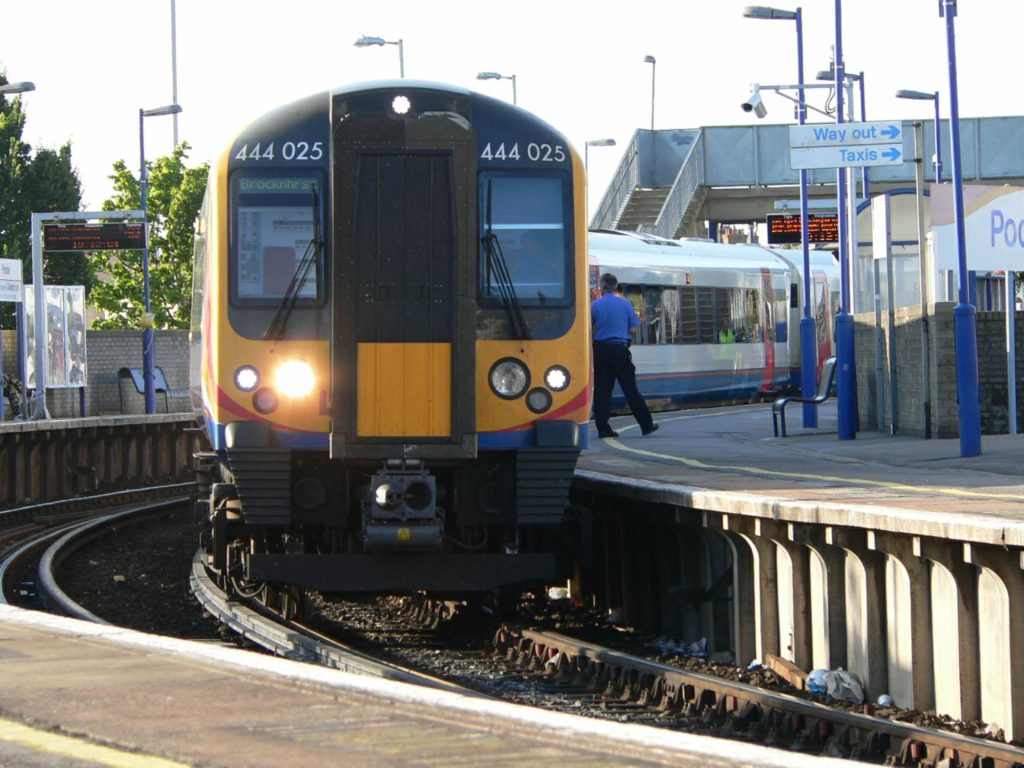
[577,401,1024,546]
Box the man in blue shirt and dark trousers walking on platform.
[590,272,658,437]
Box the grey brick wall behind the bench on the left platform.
[0,330,191,418]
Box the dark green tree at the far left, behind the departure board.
[0,74,85,328]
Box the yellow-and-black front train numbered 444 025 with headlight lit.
[191,81,590,594]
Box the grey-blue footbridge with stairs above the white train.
[591,117,1024,239]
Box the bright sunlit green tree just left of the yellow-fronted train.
[89,142,209,329]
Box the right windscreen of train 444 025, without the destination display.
[479,172,572,307]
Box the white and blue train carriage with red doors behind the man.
[589,230,840,410]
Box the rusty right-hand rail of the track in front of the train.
[495,628,1024,768]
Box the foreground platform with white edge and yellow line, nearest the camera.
[0,605,852,768]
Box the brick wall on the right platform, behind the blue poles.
[854,302,1024,437]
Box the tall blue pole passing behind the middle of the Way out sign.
[836,0,857,440]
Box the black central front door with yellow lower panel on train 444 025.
[331,96,476,460]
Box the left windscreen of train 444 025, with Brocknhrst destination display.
[231,173,325,302]
